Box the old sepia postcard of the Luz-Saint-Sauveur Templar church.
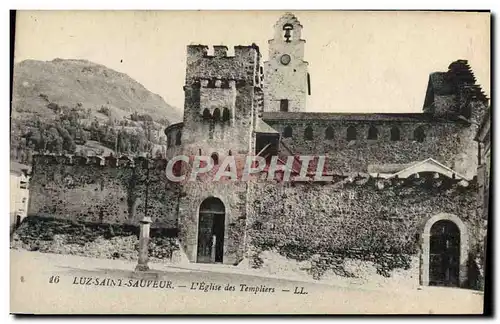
[10,10,491,315]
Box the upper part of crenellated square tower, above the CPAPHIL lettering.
[183,45,261,161]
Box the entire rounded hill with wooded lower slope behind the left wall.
[10,59,181,164]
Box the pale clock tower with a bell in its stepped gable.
[264,13,310,112]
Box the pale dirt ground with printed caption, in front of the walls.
[10,250,483,314]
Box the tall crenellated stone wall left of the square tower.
[28,156,179,228]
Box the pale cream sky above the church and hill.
[14,11,490,112]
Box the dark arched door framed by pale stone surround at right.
[429,220,460,287]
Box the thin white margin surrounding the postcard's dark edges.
[0,0,500,323]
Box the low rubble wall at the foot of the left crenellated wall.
[11,216,180,262]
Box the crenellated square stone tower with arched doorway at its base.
[174,45,263,264]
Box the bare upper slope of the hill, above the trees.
[12,59,181,123]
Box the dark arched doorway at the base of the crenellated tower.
[196,197,226,263]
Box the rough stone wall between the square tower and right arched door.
[246,177,483,288]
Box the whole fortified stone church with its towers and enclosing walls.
[26,13,488,287]
